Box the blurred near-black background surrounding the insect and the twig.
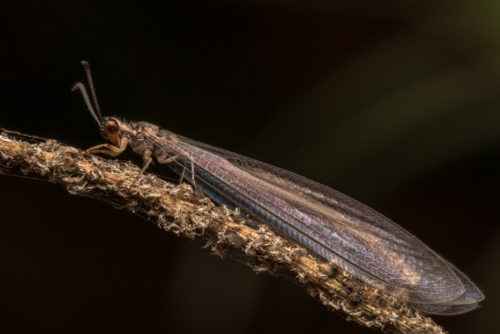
[0,0,500,333]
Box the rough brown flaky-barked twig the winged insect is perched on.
[0,131,444,333]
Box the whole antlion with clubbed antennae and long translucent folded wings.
[73,61,484,315]
